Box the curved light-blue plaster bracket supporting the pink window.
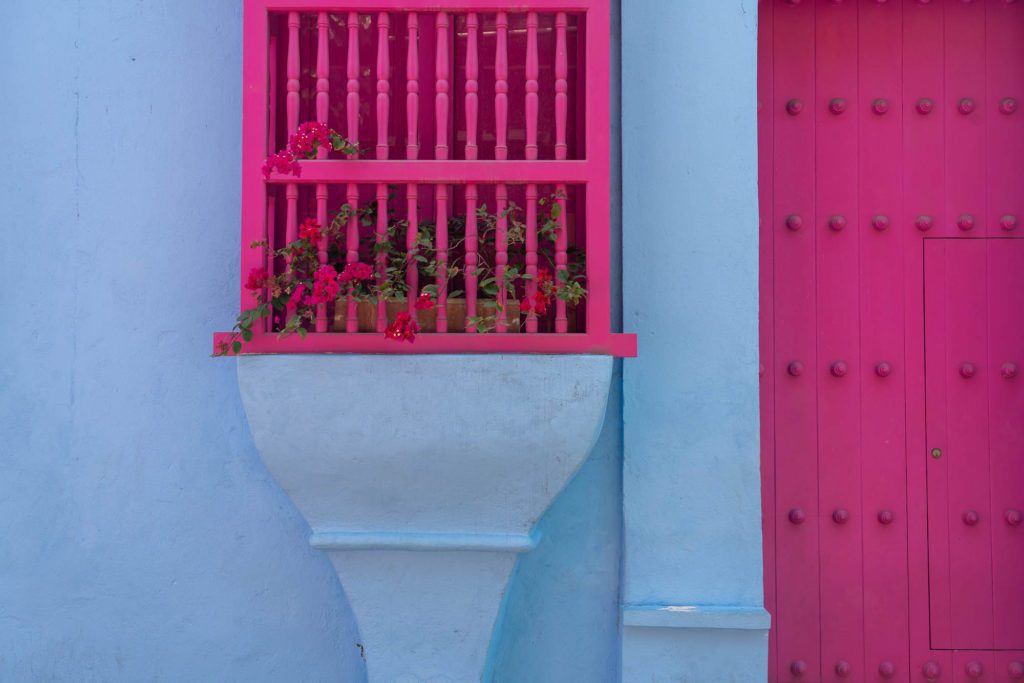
[238,355,612,683]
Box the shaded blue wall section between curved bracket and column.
[490,360,623,683]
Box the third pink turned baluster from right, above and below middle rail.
[495,12,509,332]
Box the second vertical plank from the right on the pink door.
[942,2,995,663]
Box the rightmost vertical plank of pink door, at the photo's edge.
[985,0,1024,655]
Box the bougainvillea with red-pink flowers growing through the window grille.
[215,122,587,355]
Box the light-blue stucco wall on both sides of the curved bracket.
[0,0,622,683]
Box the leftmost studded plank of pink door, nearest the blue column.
[771,2,822,681]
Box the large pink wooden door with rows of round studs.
[758,0,1024,682]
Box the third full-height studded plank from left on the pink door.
[851,2,920,682]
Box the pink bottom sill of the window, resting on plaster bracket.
[213,332,637,358]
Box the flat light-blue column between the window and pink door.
[623,0,769,683]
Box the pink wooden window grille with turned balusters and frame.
[217,0,636,356]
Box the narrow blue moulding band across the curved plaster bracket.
[309,530,540,553]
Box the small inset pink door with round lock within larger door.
[925,239,1024,650]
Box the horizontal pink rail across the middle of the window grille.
[270,159,593,184]
